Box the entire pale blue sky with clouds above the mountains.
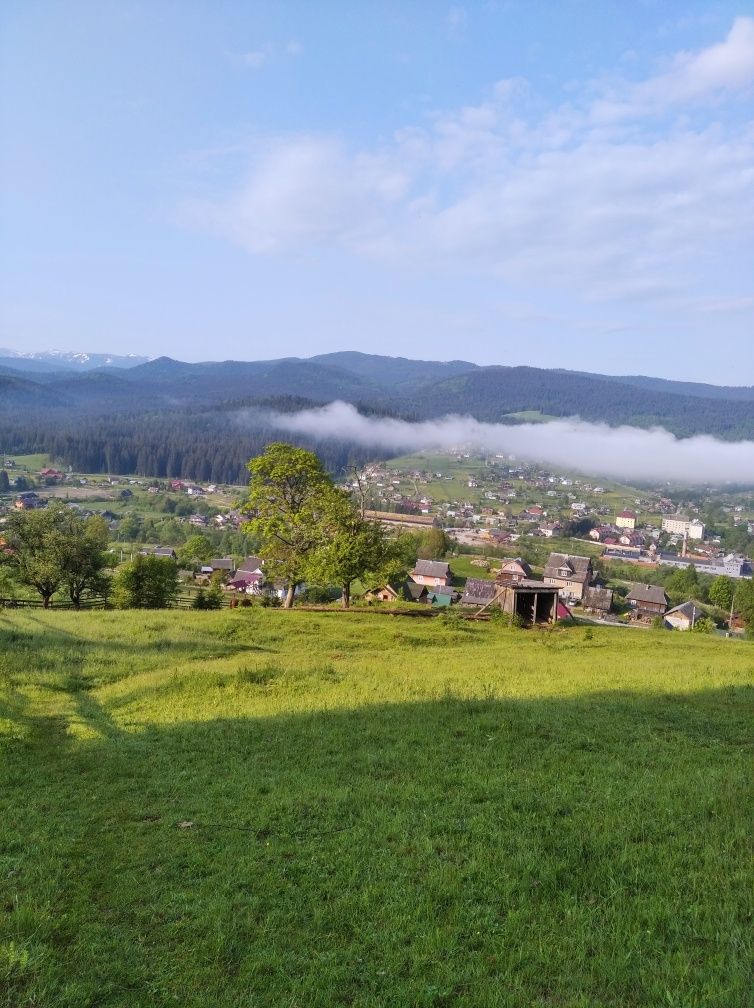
[0,0,754,384]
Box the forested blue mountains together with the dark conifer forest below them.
[0,352,754,482]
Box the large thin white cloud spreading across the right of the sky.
[198,17,754,301]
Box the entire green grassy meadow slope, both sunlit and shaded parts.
[0,610,754,1008]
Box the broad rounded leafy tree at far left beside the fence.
[4,501,108,609]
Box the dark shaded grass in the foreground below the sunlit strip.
[0,686,754,1008]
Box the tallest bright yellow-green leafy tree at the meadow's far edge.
[244,442,337,609]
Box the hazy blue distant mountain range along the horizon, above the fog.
[0,351,754,439]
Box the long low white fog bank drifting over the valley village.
[271,402,754,485]
